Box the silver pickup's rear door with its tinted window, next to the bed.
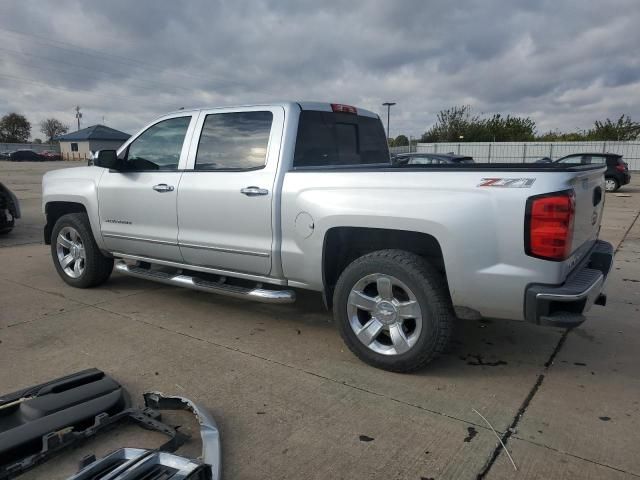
[178,107,284,275]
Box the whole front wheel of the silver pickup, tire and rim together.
[51,213,113,288]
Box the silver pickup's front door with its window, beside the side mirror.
[98,114,196,261]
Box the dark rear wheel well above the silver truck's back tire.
[322,227,446,307]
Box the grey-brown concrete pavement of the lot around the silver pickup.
[0,162,640,479]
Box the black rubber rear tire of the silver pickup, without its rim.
[333,250,455,372]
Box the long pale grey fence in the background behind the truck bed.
[410,142,640,171]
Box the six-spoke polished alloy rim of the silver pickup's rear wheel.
[347,273,422,355]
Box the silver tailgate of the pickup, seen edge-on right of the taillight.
[571,167,605,252]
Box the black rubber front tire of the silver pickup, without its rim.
[51,213,113,288]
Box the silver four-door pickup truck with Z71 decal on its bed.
[43,102,613,371]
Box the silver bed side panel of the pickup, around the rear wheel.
[282,169,597,319]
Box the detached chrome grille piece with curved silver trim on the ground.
[69,392,222,480]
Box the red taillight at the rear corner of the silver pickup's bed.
[524,190,576,261]
